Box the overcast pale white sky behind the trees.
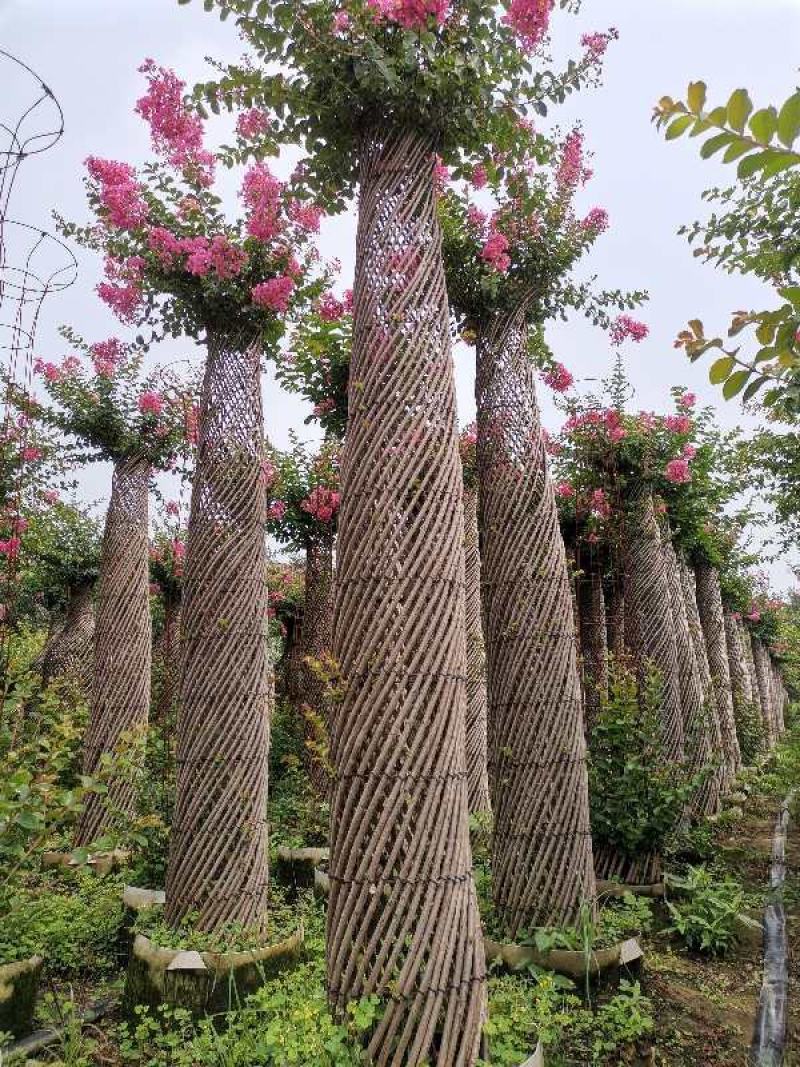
[0,0,800,587]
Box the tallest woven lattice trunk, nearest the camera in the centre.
[327,126,485,1067]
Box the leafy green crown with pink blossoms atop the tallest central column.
[183,0,607,207]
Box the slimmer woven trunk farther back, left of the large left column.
[76,456,151,846]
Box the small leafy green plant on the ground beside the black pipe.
[667,866,745,956]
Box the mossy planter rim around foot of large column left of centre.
[123,929,303,1018]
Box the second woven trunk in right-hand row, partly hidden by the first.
[663,531,717,814]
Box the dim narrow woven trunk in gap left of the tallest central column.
[300,530,334,796]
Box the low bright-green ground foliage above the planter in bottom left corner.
[0,870,123,977]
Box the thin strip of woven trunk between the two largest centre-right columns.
[464,485,491,812]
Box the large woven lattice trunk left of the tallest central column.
[165,332,270,930]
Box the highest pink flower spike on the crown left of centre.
[135,60,214,186]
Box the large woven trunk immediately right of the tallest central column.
[476,309,594,936]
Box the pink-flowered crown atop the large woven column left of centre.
[60,60,322,348]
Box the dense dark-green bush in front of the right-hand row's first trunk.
[589,664,698,857]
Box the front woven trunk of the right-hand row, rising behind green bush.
[624,485,684,762]
